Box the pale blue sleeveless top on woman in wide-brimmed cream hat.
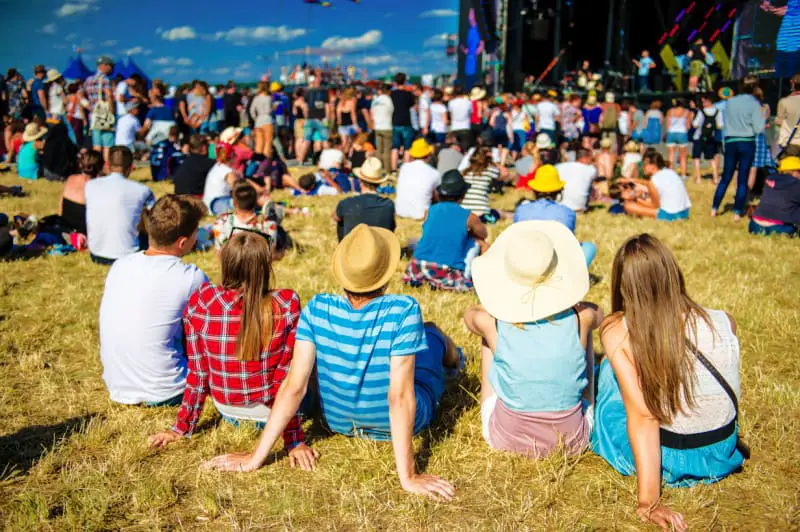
[489,309,589,412]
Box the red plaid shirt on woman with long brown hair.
[172,283,305,449]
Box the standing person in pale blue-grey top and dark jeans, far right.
[711,74,764,221]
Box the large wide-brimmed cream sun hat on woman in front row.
[472,221,589,323]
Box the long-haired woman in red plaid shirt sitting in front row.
[148,233,317,469]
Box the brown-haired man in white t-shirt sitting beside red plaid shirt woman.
[99,195,208,406]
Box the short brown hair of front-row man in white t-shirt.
[142,194,208,247]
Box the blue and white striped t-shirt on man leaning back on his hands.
[297,294,431,440]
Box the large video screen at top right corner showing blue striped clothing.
[732,0,800,79]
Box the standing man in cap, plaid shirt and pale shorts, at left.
[83,55,116,162]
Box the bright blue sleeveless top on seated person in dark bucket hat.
[414,201,473,270]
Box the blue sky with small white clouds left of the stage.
[0,0,458,82]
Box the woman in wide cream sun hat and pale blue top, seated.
[464,221,603,458]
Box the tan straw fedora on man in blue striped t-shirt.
[333,224,400,294]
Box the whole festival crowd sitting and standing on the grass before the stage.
[0,57,800,530]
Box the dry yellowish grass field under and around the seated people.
[0,167,800,530]
